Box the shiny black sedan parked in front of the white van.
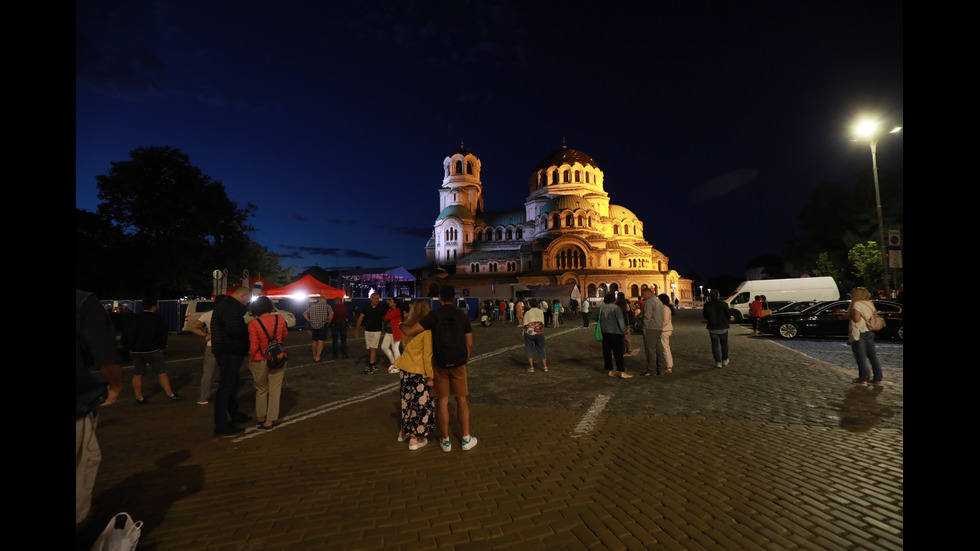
[759,300,905,341]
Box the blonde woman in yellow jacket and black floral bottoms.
[398,300,436,450]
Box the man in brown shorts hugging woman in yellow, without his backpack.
[402,285,476,452]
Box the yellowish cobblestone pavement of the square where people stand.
[76,310,904,550]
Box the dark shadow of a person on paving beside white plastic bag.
[75,450,204,551]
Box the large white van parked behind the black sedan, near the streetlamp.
[726,277,840,323]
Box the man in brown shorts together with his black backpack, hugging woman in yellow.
[402,285,476,452]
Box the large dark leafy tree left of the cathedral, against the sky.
[88,147,272,298]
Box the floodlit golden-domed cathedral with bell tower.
[425,146,693,305]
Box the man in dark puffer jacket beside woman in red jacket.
[211,287,252,436]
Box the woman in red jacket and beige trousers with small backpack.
[248,296,287,430]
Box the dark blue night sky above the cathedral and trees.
[75,0,903,278]
